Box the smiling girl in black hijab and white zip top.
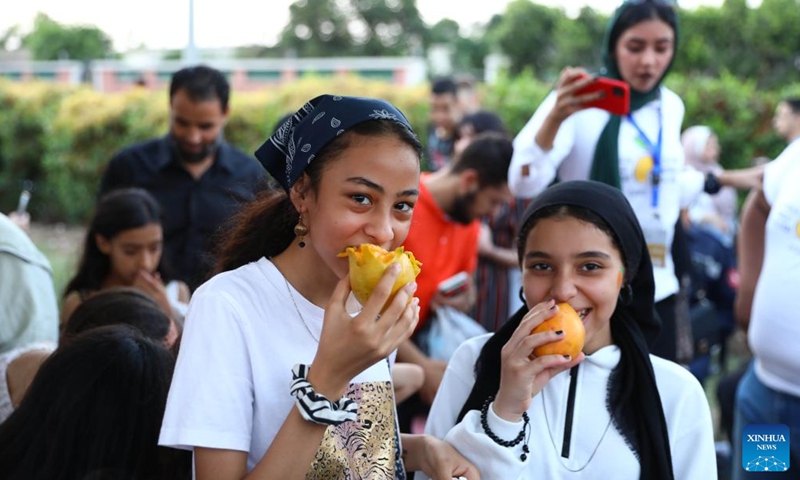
[426,181,717,480]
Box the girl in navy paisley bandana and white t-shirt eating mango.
[159,95,478,480]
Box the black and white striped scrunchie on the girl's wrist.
[290,363,358,425]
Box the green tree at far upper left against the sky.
[22,13,114,60]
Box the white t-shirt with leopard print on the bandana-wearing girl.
[159,258,403,480]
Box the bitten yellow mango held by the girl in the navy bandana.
[338,243,422,306]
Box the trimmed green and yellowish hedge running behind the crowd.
[0,73,800,223]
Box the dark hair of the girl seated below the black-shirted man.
[64,188,172,296]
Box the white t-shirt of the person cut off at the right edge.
[747,138,800,397]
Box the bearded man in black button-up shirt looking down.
[100,65,267,290]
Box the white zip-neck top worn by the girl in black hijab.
[418,334,717,480]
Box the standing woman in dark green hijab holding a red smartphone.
[509,0,706,360]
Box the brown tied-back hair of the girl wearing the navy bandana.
[214,120,422,274]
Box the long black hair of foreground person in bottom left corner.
[0,325,191,480]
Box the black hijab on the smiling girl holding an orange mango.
[458,181,674,480]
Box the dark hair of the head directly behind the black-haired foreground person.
[59,287,171,345]
